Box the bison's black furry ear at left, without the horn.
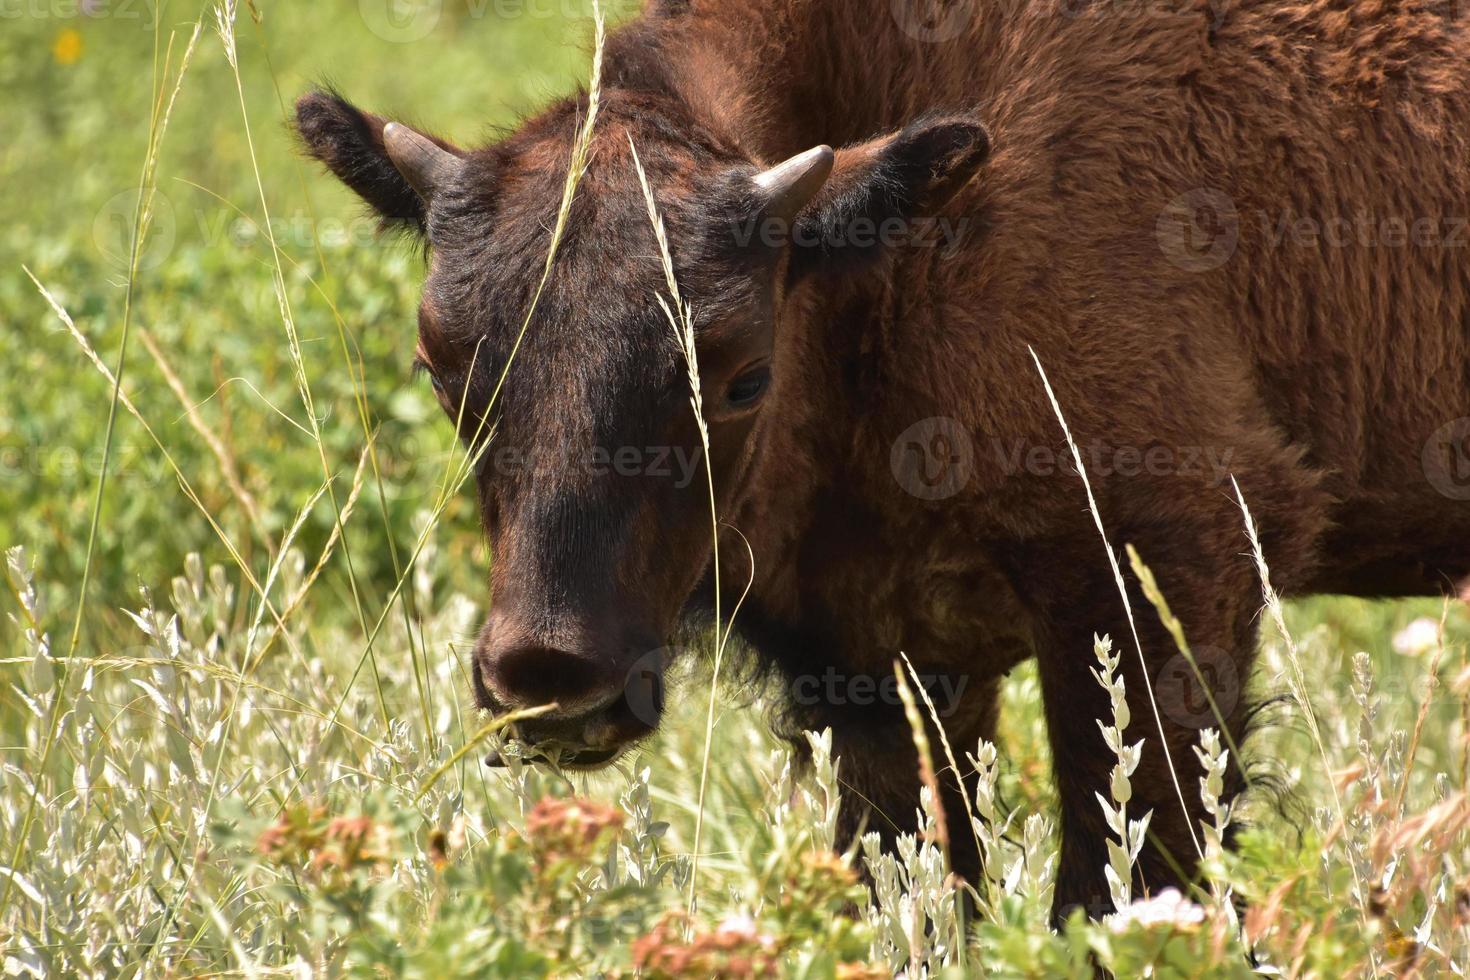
[295,90,438,229]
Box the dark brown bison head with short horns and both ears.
[297,90,988,765]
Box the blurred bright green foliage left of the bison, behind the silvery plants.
[0,0,632,637]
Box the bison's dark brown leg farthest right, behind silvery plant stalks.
[1038,529,1257,923]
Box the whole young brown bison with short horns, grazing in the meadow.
[297,0,1470,911]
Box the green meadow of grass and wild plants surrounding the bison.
[0,1,1470,977]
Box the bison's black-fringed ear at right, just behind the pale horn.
[789,116,991,279]
